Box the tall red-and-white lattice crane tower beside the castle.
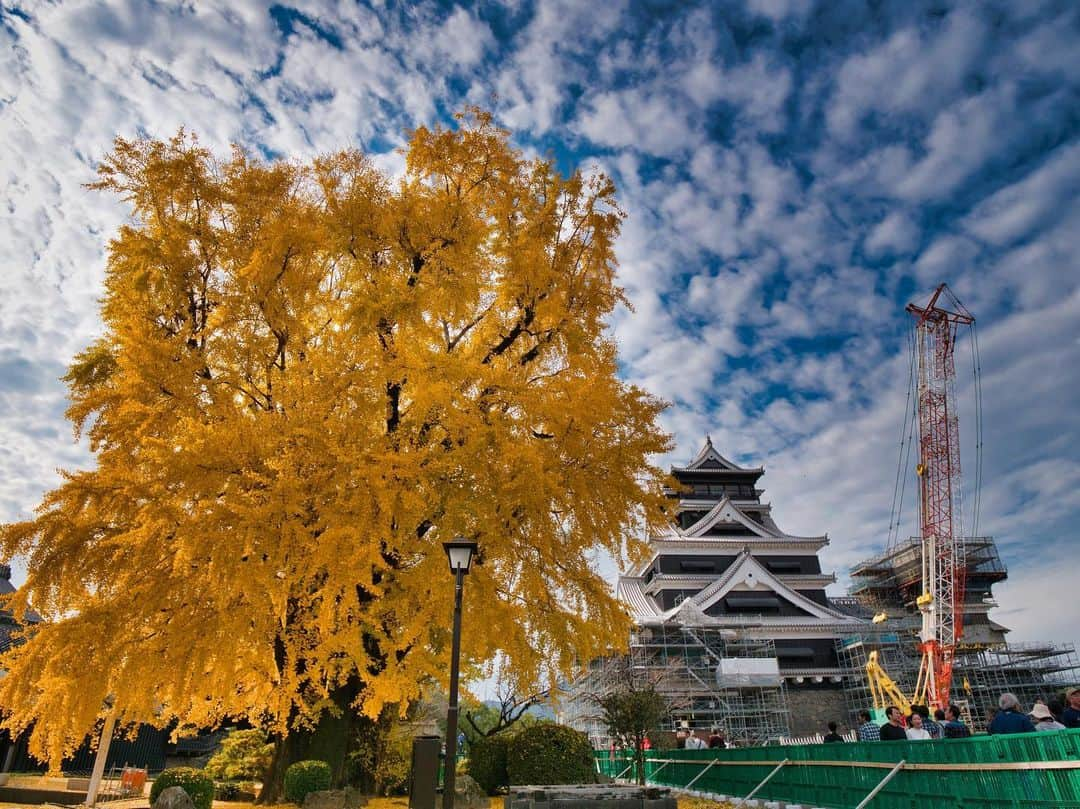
[907,284,975,707]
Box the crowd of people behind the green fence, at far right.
[846,688,1080,742]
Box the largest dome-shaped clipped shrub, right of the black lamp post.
[507,722,596,784]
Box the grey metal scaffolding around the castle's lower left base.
[562,622,789,747]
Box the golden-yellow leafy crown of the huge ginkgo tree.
[0,110,670,796]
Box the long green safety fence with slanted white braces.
[596,729,1080,809]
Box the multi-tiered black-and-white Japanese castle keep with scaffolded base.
[566,439,868,744]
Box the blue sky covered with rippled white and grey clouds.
[0,0,1080,642]
